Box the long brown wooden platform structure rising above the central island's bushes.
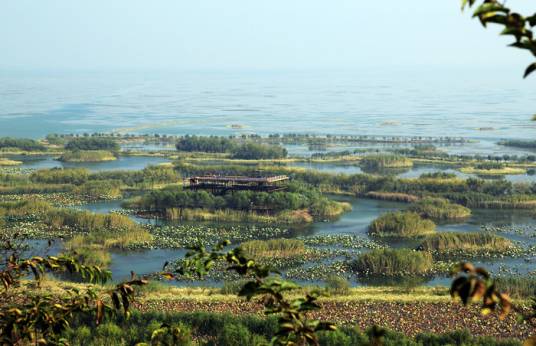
[183,175,289,193]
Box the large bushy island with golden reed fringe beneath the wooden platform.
[125,183,351,224]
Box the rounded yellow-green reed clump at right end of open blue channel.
[368,211,435,238]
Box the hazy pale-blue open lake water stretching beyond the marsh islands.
[0,68,536,139]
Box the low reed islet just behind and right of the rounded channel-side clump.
[410,197,471,220]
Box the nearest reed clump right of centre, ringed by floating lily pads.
[350,249,433,276]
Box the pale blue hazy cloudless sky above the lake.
[0,0,531,74]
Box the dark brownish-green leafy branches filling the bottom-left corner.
[0,253,146,345]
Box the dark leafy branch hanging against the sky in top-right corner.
[462,0,536,77]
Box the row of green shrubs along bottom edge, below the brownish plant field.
[58,311,521,346]
